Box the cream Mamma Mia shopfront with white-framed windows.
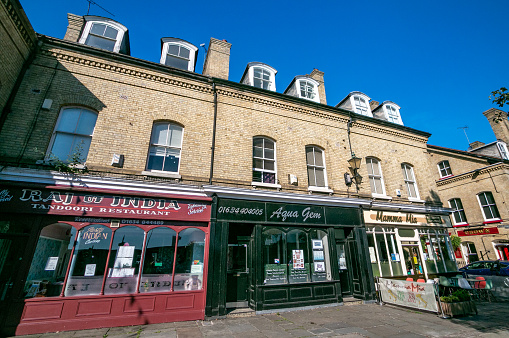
[364,210,457,278]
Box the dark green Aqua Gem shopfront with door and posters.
[206,198,374,316]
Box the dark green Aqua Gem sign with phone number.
[217,199,360,225]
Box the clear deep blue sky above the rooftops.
[20,0,509,150]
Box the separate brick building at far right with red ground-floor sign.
[428,108,509,265]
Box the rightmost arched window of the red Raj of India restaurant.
[173,228,205,291]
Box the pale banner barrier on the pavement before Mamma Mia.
[379,278,438,312]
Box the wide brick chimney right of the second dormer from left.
[203,38,232,80]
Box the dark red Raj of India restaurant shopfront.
[0,186,211,335]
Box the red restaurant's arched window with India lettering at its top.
[65,224,112,296]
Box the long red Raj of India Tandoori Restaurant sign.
[0,187,210,222]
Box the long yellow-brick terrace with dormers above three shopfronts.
[0,0,456,334]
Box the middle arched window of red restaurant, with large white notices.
[104,226,145,295]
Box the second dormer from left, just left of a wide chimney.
[161,38,198,72]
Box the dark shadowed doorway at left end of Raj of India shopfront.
[0,233,28,336]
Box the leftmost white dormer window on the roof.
[79,15,129,54]
